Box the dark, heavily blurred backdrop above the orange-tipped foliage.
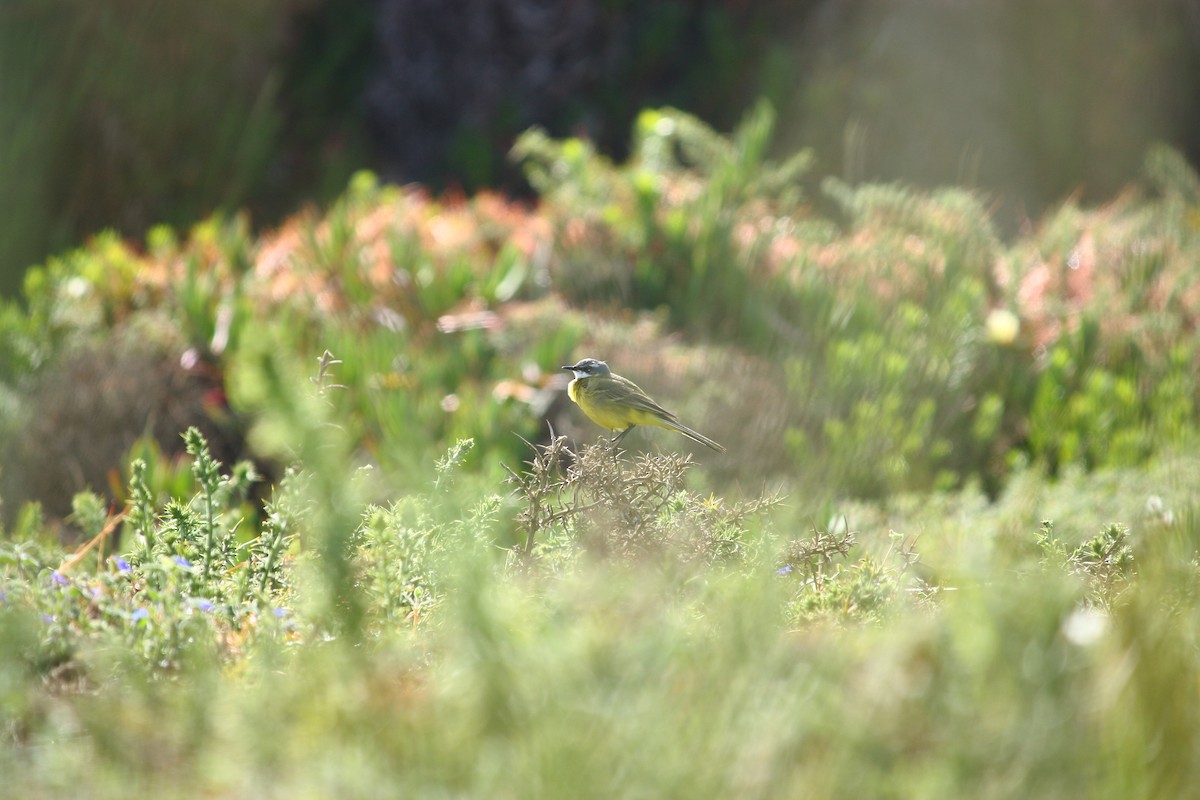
[0,0,1200,294]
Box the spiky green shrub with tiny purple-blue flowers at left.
[2,428,296,669]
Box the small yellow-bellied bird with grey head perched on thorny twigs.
[563,359,725,452]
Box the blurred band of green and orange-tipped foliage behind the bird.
[0,102,1200,518]
